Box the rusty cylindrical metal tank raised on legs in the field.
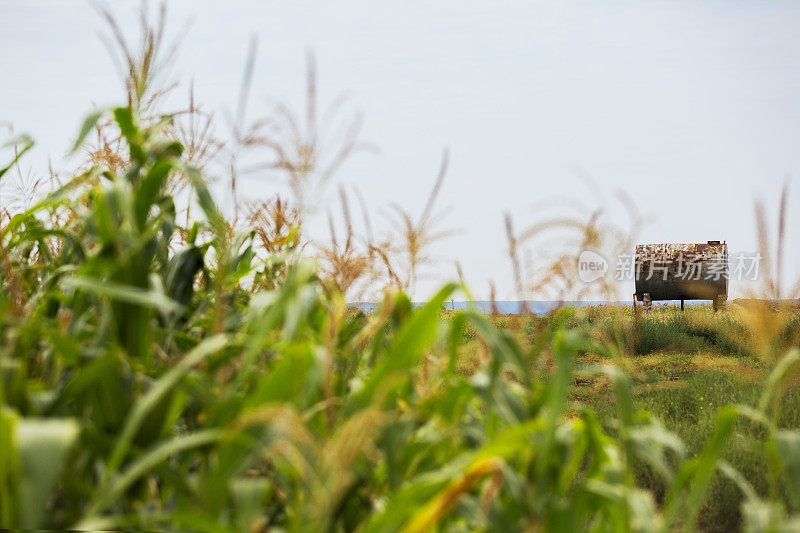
[634,241,728,309]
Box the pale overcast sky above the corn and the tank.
[0,0,800,299]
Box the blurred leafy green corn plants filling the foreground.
[0,103,800,531]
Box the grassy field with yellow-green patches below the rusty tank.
[460,302,800,531]
